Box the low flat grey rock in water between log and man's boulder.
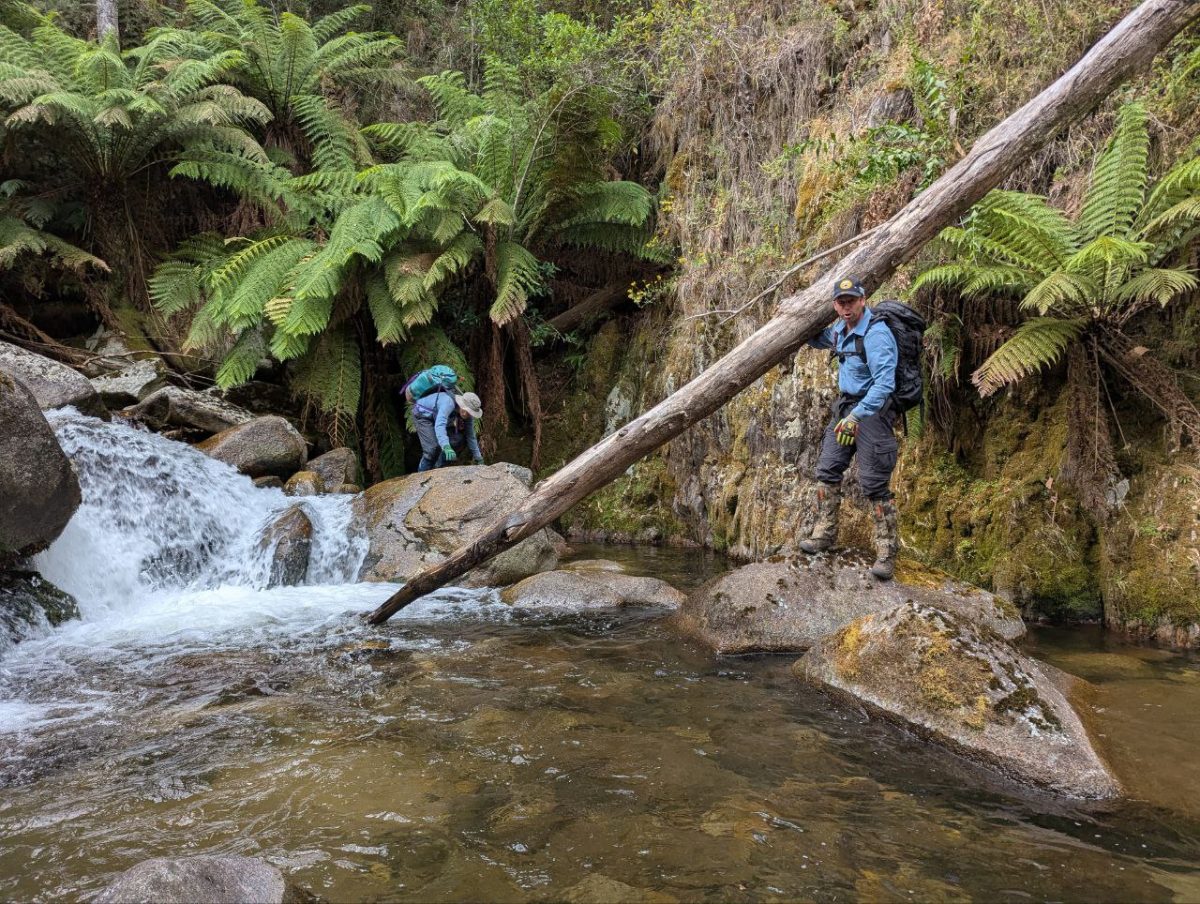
[500,563,686,611]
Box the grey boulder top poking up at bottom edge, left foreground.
[92,857,298,904]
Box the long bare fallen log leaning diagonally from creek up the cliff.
[367,0,1200,624]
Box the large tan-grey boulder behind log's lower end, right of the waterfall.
[354,463,558,587]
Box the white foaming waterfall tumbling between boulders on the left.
[35,409,366,619]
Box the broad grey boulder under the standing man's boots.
[678,552,1025,653]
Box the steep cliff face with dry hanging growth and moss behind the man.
[546,0,1200,642]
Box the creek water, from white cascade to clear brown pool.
[0,413,1200,902]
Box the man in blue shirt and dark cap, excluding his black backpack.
[800,277,900,581]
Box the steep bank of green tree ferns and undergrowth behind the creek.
[0,0,1200,622]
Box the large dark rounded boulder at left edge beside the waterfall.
[0,371,80,567]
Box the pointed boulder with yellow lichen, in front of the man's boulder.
[794,603,1120,798]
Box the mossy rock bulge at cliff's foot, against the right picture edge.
[1103,461,1200,648]
